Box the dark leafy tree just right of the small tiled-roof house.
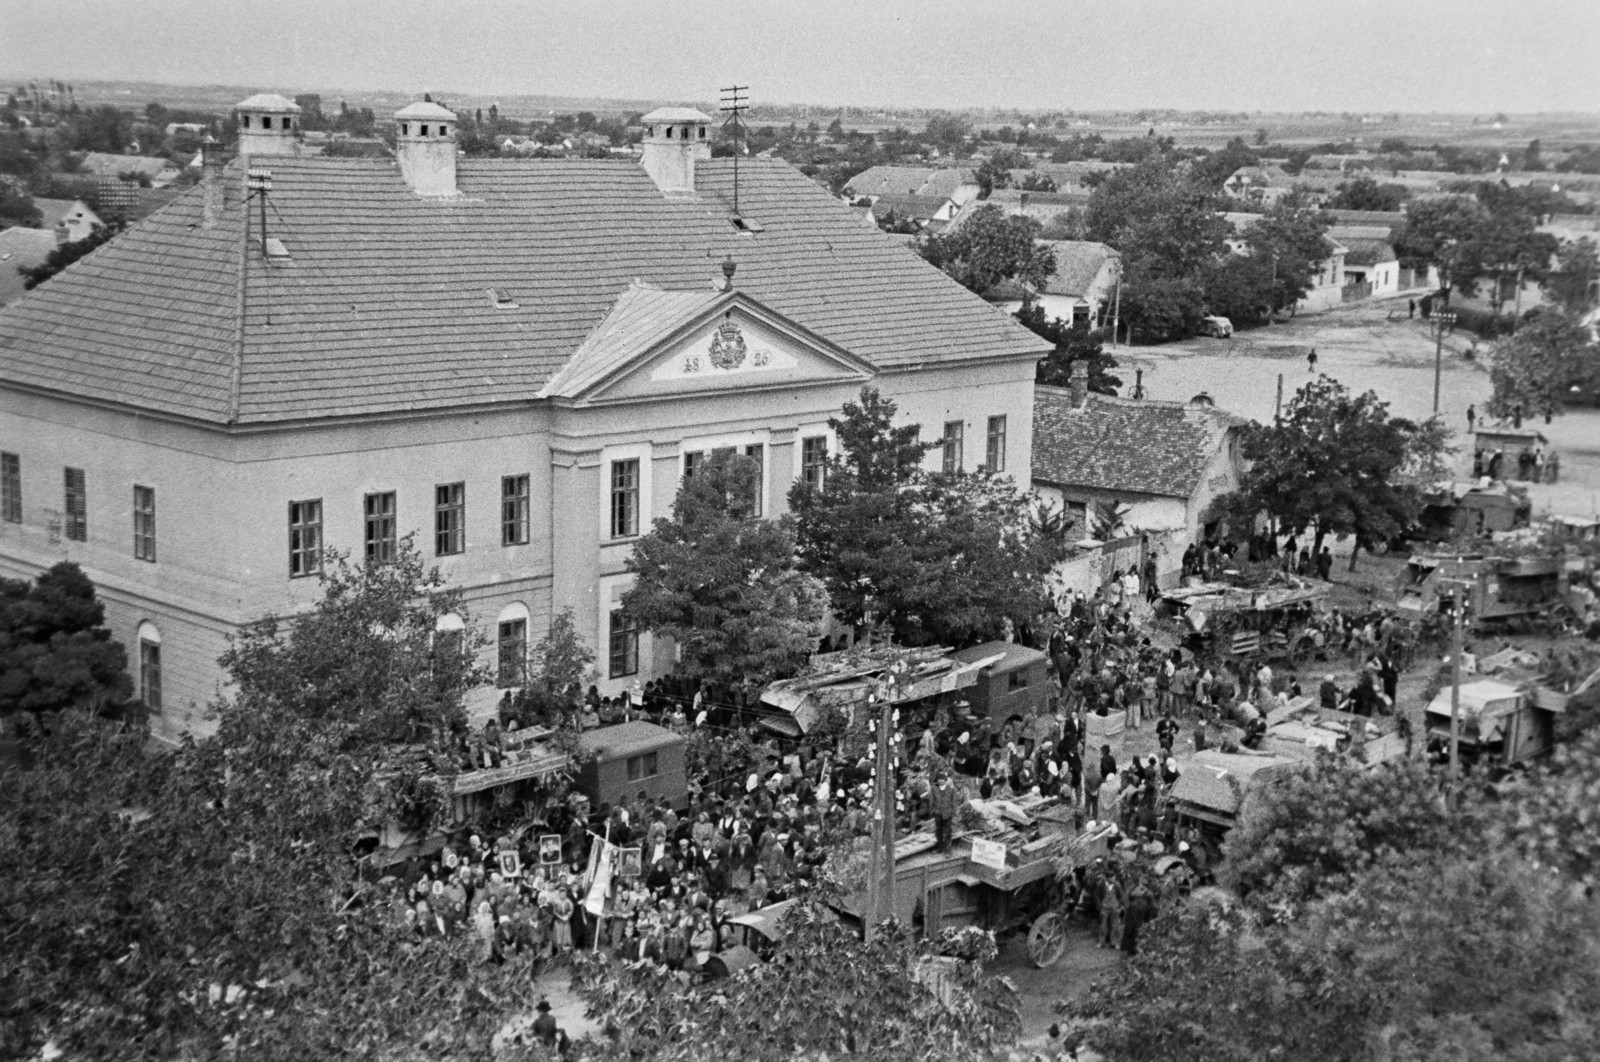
[1224,376,1434,571]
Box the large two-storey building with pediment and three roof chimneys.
[0,98,1048,737]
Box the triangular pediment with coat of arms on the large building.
[546,288,874,403]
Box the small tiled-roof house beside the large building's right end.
[1034,361,1246,542]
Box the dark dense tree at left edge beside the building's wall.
[0,560,133,715]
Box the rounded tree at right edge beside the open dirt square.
[1486,309,1600,419]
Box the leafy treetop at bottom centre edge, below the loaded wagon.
[574,899,1018,1062]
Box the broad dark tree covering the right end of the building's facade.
[789,387,1054,645]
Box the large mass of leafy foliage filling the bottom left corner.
[0,549,533,1060]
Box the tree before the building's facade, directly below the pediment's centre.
[622,454,827,689]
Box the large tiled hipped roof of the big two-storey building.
[0,155,1048,424]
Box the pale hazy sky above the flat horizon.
[0,0,1600,114]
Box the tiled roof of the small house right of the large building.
[1034,385,1245,497]
